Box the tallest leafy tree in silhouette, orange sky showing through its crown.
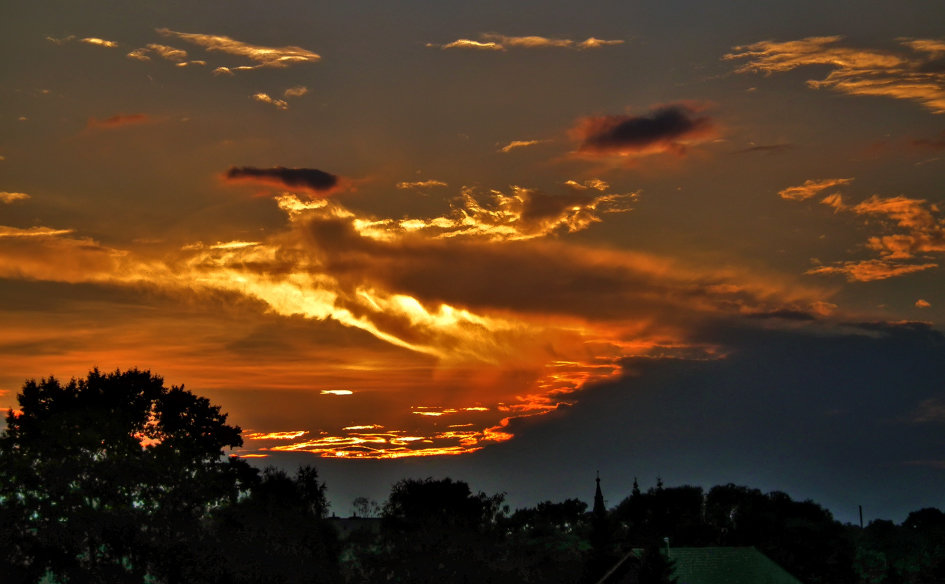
[0,369,255,582]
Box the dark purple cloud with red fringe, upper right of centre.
[572,103,715,155]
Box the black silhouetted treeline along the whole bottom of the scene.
[0,370,945,584]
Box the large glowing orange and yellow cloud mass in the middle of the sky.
[0,176,821,458]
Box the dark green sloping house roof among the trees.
[669,547,801,584]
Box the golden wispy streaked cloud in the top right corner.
[723,36,945,114]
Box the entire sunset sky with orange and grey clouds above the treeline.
[0,0,945,521]
